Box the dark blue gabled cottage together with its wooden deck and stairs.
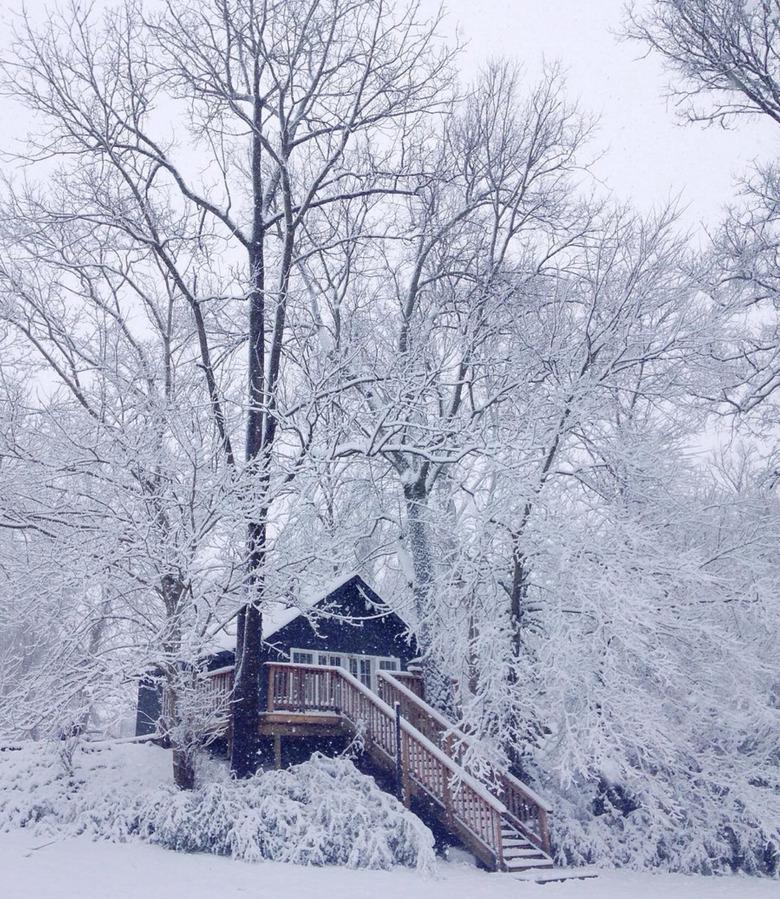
[136,575,561,879]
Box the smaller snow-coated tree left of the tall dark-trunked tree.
[0,207,247,785]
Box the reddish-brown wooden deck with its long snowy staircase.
[181,663,553,872]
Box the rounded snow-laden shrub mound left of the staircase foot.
[137,756,433,868]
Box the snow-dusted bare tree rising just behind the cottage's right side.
[317,62,589,706]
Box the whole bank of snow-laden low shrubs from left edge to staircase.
[0,744,434,869]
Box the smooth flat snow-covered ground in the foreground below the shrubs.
[0,831,780,899]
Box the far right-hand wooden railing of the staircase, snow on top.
[379,671,551,853]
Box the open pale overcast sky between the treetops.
[0,0,780,232]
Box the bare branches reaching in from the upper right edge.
[627,0,780,427]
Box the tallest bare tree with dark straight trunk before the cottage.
[6,0,458,775]
